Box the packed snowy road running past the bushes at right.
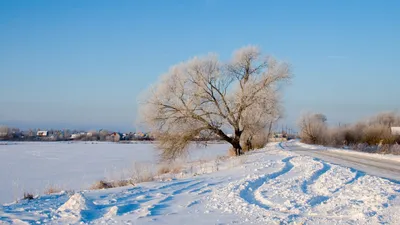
[281,142,400,182]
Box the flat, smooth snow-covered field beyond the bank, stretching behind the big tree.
[0,142,229,204]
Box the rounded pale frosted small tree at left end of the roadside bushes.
[298,113,327,144]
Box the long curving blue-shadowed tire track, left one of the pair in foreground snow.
[239,156,294,210]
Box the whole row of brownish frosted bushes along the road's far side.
[299,113,400,154]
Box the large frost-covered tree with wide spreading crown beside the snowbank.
[140,46,291,159]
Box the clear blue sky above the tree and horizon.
[0,0,400,130]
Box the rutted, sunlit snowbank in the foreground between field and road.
[0,143,400,225]
